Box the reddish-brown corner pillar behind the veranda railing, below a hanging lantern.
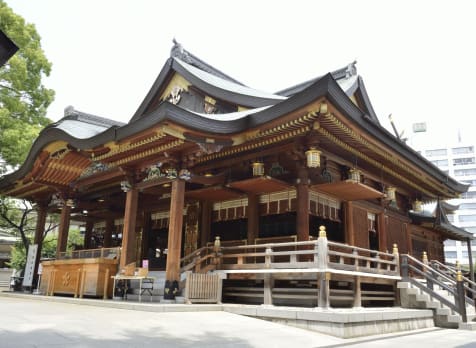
[296,167,309,242]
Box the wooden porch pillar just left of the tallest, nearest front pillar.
[120,188,139,268]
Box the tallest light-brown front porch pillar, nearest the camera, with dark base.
[165,179,185,281]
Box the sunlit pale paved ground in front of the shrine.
[0,296,476,348]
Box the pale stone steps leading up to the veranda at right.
[397,281,476,331]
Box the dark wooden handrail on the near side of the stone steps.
[400,254,474,322]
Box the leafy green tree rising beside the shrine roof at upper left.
[0,0,54,174]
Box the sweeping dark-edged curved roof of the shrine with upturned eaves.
[0,44,468,201]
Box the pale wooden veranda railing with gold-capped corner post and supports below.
[181,226,401,307]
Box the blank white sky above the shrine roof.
[5,0,476,147]
